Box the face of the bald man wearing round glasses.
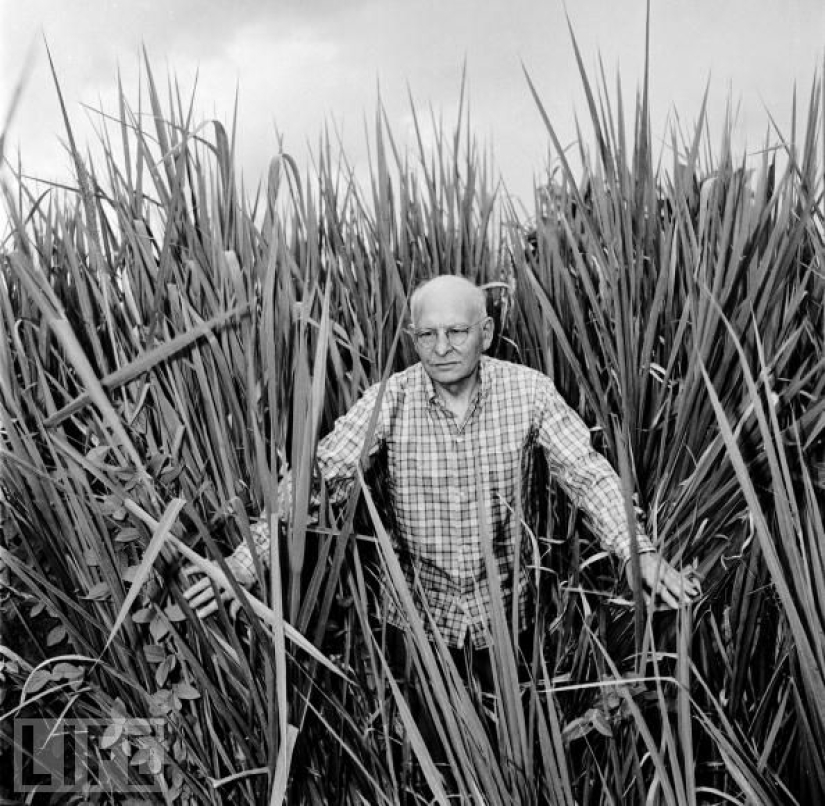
[414,289,493,386]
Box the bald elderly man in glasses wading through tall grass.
[186,276,699,649]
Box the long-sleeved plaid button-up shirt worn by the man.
[231,356,654,647]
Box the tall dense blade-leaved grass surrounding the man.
[0,38,825,804]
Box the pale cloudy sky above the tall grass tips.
[0,0,825,213]
